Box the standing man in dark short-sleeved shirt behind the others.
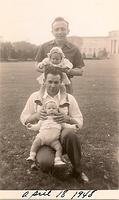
[36,17,84,93]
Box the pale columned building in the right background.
[69,31,119,58]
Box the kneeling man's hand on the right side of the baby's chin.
[53,113,70,124]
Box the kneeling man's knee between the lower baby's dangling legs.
[36,146,55,172]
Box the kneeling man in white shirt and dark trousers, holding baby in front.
[20,66,88,182]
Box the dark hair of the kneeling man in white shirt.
[44,64,63,81]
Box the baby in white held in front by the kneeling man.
[27,100,65,165]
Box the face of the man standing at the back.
[52,21,69,40]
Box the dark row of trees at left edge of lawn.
[0,41,38,61]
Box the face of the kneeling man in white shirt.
[45,74,61,96]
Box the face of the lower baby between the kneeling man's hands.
[45,102,58,115]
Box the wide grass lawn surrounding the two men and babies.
[0,60,119,190]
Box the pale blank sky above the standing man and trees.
[0,0,119,44]
